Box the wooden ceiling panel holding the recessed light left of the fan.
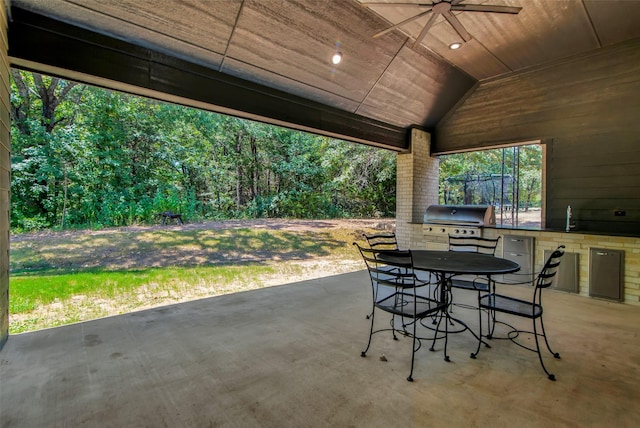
[227,0,404,102]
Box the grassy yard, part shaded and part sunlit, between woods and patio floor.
[9,222,380,334]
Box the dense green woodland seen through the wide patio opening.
[11,70,396,231]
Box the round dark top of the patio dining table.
[411,250,520,275]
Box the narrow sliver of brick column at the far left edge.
[0,0,11,349]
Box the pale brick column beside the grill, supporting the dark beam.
[396,129,439,249]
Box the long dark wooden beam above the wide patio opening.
[9,7,409,151]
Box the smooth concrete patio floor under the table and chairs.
[0,271,640,427]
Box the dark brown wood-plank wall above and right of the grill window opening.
[433,39,640,234]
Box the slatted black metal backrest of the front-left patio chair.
[354,242,416,288]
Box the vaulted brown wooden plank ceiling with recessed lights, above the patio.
[11,0,640,135]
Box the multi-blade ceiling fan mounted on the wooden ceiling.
[362,0,522,47]
